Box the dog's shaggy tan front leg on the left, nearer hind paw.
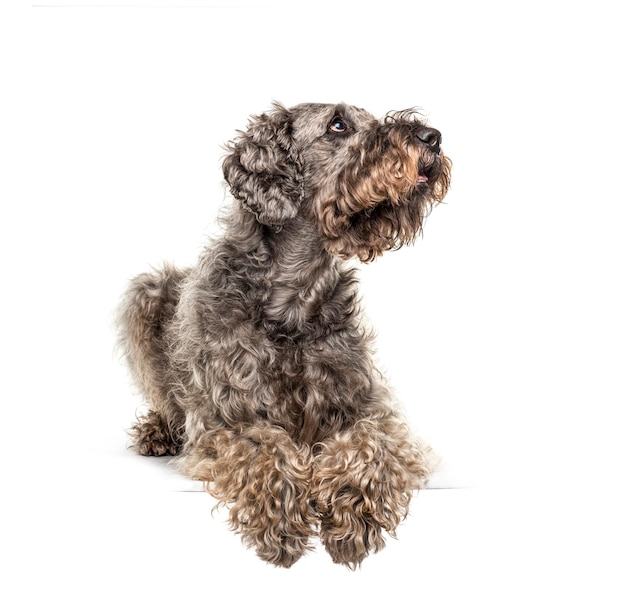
[181,423,317,568]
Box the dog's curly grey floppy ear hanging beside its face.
[222,104,304,226]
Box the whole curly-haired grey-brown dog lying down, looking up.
[120,104,451,568]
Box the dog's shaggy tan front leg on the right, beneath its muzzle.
[312,415,433,569]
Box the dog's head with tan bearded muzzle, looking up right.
[223,104,451,261]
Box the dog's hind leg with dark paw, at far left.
[118,266,187,456]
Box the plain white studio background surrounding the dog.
[0,1,626,607]
